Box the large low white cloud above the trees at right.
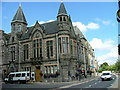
[90,38,118,65]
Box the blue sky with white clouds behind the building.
[2,2,118,64]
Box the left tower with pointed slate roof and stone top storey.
[11,5,27,33]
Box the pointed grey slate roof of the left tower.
[12,6,27,24]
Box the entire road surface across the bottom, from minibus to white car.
[2,76,116,90]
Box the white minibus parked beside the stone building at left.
[4,71,35,83]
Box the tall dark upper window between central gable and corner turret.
[46,40,53,58]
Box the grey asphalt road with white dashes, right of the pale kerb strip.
[60,76,116,90]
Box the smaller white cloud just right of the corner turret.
[73,22,100,32]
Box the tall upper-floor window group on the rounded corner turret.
[58,37,68,54]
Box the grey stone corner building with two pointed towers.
[0,3,96,81]
